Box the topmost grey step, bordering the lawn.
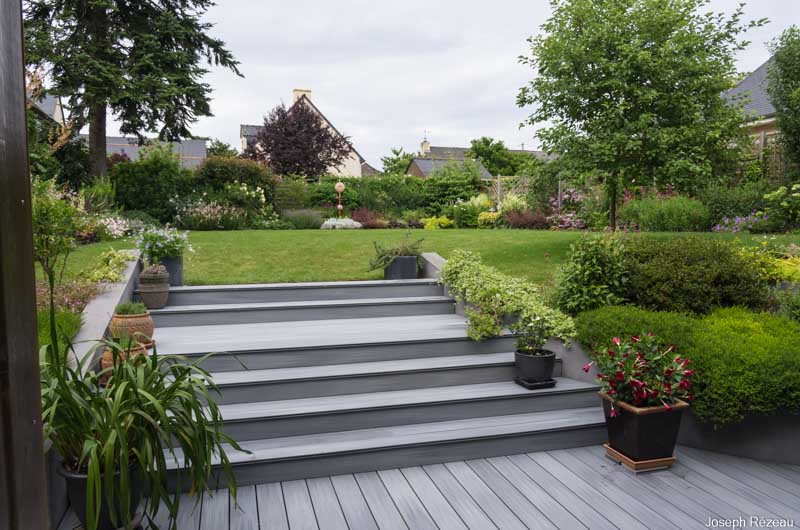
[162,278,443,306]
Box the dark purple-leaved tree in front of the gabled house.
[245,100,352,179]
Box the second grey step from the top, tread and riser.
[150,296,455,328]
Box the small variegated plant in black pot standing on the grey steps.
[509,295,574,390]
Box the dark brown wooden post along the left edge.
[0,0,49,530]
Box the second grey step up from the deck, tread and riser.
[214,378,598,441]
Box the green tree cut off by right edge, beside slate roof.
[767,26,800,168]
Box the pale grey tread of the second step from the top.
[150,296,455,316]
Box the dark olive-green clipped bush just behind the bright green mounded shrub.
[624,237,768,314]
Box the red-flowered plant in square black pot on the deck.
[584,333,694,465]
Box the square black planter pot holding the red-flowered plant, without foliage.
[600,392,689,461]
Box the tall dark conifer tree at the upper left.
[25,0,240,176]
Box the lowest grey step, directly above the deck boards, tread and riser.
[168,404,606,485]
